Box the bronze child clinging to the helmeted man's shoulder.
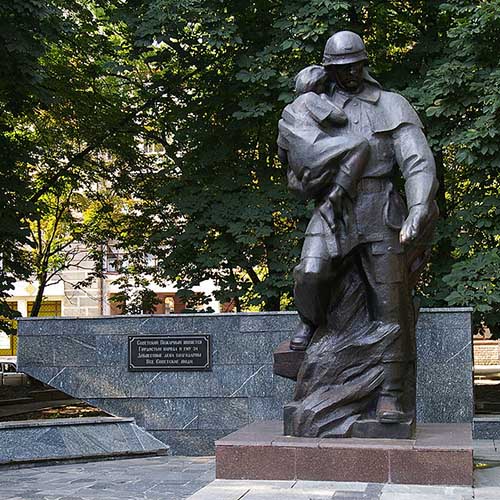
[278,65,369,243]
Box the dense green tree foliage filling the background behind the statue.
[0,0,500,334]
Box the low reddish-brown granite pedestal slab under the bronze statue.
[215,421,473,486]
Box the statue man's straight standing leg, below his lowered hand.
[360,243,414,422]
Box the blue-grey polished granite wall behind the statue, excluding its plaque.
[18,309,473,455]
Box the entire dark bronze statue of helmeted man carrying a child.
[278,31,438,437]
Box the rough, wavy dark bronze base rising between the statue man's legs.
[274,262,415,439]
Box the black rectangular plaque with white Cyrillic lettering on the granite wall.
[128,335,212,371]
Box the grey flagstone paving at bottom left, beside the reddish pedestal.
[0,458,215,500]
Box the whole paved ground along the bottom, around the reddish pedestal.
[0,440,500,500]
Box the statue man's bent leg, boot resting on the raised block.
[290,211,333,350]
